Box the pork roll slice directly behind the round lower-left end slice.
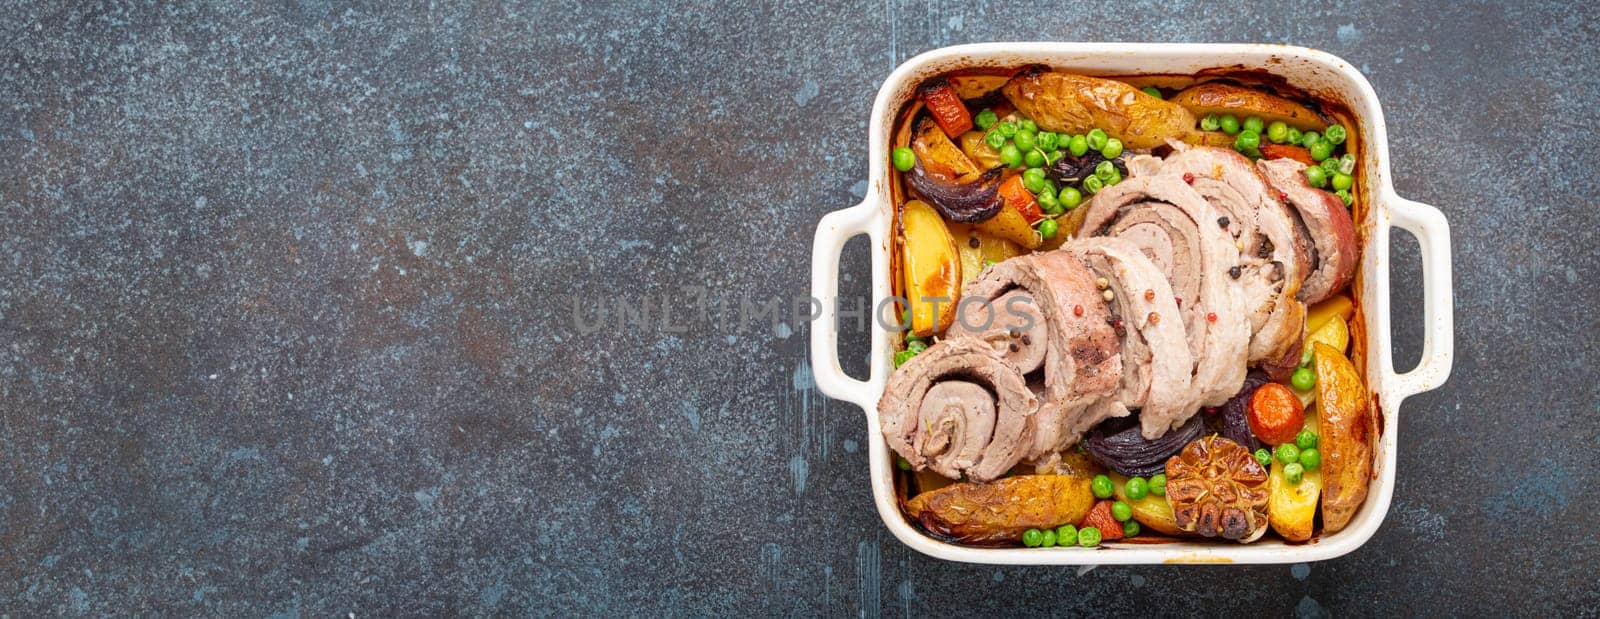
[947,251,1122,461]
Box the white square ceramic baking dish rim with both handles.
[811,43,1453,565]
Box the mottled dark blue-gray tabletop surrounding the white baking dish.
[0,2,1600,616]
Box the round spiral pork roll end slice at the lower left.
[878,337,1038,481]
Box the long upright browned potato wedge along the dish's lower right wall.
[1312,342,1378,533]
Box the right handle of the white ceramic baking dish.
[1379,197,1456,401]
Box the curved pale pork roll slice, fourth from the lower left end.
[1078,174,1250,413]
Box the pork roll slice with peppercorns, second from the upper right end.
[1162,147,1310,371]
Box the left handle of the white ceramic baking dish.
[811,197,888,411]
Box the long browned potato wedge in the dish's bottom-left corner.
[906,475,1094,544]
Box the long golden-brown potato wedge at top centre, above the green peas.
[1002,72,1197,149]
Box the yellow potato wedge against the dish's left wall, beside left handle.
[901,200,962,337]
